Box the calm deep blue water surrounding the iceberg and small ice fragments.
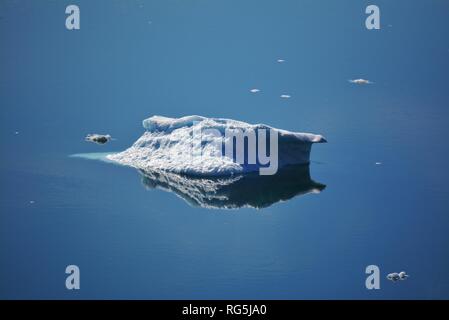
[0,0,449,299]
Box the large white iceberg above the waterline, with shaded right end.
[108,116,326,176]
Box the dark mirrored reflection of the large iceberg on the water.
[139,165,326,209]
